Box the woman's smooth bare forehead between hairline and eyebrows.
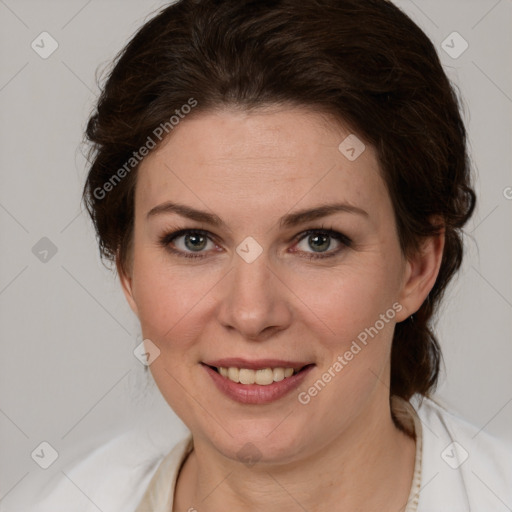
[136,109,387,222]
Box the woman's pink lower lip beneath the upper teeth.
[202,364,314,404]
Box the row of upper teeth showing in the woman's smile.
[202,363,314,386]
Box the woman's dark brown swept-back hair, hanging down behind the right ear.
[83,0,475,400]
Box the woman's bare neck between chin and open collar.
[173,401,415,512]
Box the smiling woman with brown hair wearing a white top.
[30,0,512,512]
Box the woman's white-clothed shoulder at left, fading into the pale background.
[26,430,191,512]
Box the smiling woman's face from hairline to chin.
[122,109,432,462]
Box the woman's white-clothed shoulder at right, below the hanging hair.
[411,397,512,512]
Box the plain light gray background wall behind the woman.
[0,0,512,512]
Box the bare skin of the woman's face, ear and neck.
[118,107,444,512]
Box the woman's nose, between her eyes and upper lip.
[218,251,292,341]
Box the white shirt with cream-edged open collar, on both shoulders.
[24,396,512,512]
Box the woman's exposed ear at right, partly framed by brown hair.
[397,221,445,322]
